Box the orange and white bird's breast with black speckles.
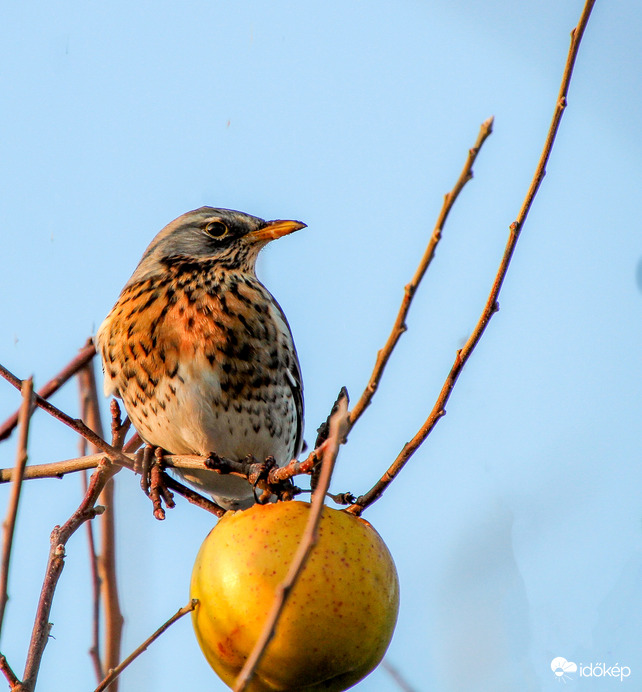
[97,272,296,463]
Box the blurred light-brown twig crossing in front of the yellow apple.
[233,398,348,692]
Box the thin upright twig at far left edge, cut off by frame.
[0,377,33,632]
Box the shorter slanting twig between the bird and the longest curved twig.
[350,117,493,428]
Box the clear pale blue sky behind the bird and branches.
[0,0,642,692]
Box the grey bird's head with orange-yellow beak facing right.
[127,207,305,286]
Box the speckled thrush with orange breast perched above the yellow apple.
[95,207,306,509]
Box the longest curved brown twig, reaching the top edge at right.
[346,0,595,515]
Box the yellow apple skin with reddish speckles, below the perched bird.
[191,501,399,692]
